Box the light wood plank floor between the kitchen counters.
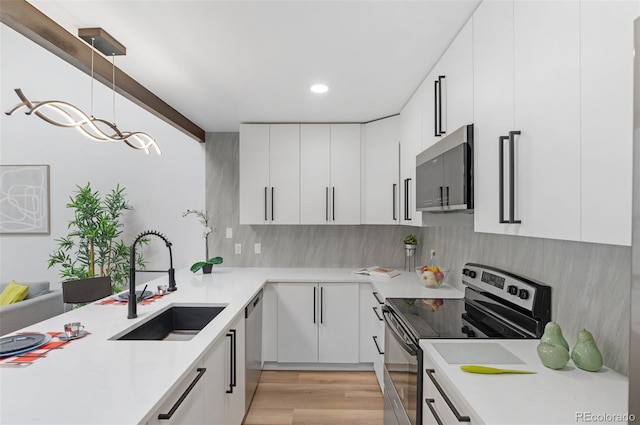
[244,371,383,425]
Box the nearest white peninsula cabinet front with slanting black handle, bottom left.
[147,359,205,425]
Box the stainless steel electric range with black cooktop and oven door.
[383,263,551,425]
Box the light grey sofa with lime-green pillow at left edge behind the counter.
[0,281,64,335]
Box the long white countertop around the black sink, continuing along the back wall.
[0,267,463,424]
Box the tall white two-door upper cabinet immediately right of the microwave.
[473,1,580,240]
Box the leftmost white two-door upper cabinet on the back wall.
[240,124,300,224]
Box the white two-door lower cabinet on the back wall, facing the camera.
[277,283,360,364]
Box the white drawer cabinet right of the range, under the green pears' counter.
[422,353,484,425]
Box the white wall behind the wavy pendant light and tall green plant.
[0,25,205,286]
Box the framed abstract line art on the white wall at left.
[0,165,50,234]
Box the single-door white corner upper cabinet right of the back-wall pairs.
[363,115,401,224]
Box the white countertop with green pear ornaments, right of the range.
[420,339,628,425]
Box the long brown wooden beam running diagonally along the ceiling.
[0,0,205,143]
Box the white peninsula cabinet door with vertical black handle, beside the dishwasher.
[204,314,245,425]
